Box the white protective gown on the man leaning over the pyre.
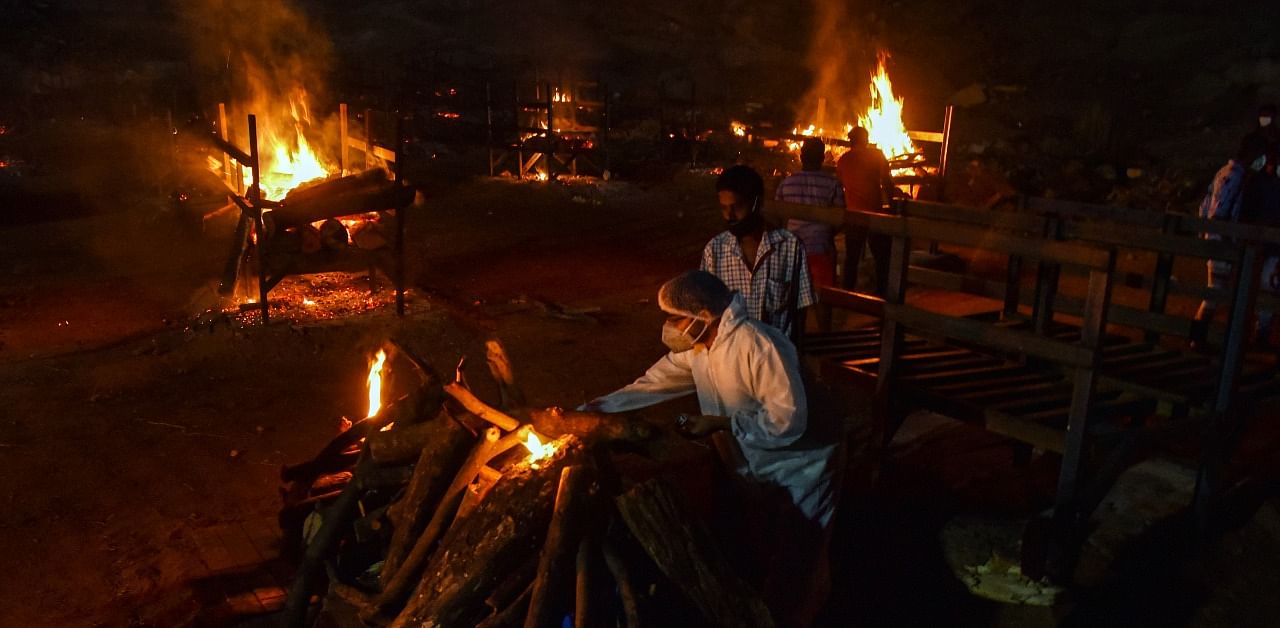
[590,294,836,526]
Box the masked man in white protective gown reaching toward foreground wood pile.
[584,271,838,624]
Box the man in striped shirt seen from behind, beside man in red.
[774,137,845,331]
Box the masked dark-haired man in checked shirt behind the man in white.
[701,165,815,341]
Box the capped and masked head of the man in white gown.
[658,270,733,353]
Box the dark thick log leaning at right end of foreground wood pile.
[614,480,774,627]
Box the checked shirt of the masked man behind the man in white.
[701,229,815,336]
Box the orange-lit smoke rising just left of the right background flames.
[796,0,876,130]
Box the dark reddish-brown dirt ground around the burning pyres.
[0,175,1280,627]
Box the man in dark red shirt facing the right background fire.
[836,127,893,294]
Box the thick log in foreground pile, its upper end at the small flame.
[392,436,584,627]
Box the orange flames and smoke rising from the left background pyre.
[183,0,338,198]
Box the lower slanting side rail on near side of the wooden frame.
[884,303,1094,367]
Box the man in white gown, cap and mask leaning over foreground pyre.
[582,270,840,627]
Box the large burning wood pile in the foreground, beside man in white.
[280,341,773,627]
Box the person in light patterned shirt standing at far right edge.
[1193,133,1267,344]
